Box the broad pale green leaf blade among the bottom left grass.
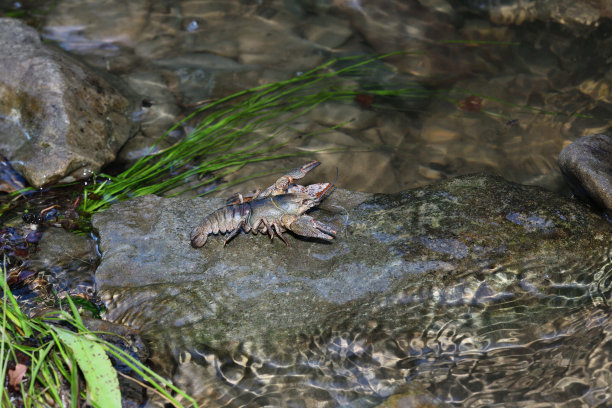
[52,326,121,408]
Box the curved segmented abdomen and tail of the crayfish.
[191,203,251,248]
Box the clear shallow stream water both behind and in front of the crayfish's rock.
[1,0,612,406]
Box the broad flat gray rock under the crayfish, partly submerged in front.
[93,176,612,406]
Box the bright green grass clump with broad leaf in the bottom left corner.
[0,262,197,408]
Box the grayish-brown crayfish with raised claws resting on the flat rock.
[191,160,336,248]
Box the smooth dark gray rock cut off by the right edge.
[559,134,612,211]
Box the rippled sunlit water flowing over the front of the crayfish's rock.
[142,247,612,407]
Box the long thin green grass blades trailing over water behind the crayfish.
[80,53,430,214]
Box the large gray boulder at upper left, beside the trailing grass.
[0,18,136,187]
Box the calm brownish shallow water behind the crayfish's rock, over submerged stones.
[9,0,612,192]
